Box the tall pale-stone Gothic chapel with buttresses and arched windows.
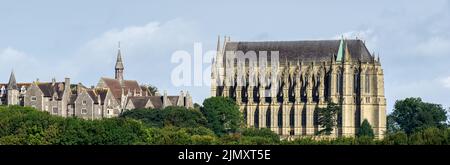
[211,37,386,138]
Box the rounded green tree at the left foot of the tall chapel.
[201,97,242,135]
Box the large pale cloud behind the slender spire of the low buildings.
[62,19,197,81]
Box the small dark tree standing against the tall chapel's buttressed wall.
[316,102,341,135]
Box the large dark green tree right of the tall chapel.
[391,98,447,135]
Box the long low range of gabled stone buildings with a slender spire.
[0,43,193,119]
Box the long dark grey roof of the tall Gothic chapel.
[225,40,373,65]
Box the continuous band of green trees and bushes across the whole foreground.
[0,98,450,145]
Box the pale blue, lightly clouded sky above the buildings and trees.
[0,0,450,112]
